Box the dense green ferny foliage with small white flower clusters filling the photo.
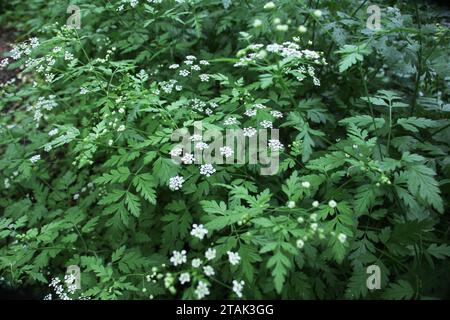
[0,0,450,299]
